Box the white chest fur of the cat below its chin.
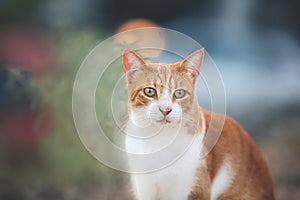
[126,125,204,200]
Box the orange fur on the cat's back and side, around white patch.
[189,111,274,200]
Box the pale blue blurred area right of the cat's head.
[167,16,300,117]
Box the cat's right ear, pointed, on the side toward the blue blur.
[180,48,204,79]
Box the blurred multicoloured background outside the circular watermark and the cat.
[0,0,300,200]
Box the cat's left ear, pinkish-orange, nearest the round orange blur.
[122,49,146,74]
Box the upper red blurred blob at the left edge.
[0,28,54,73]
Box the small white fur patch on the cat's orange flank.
[210,159,235,200]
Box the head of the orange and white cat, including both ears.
[122,48,204,127]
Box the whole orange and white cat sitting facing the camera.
[122,48,274,200]
